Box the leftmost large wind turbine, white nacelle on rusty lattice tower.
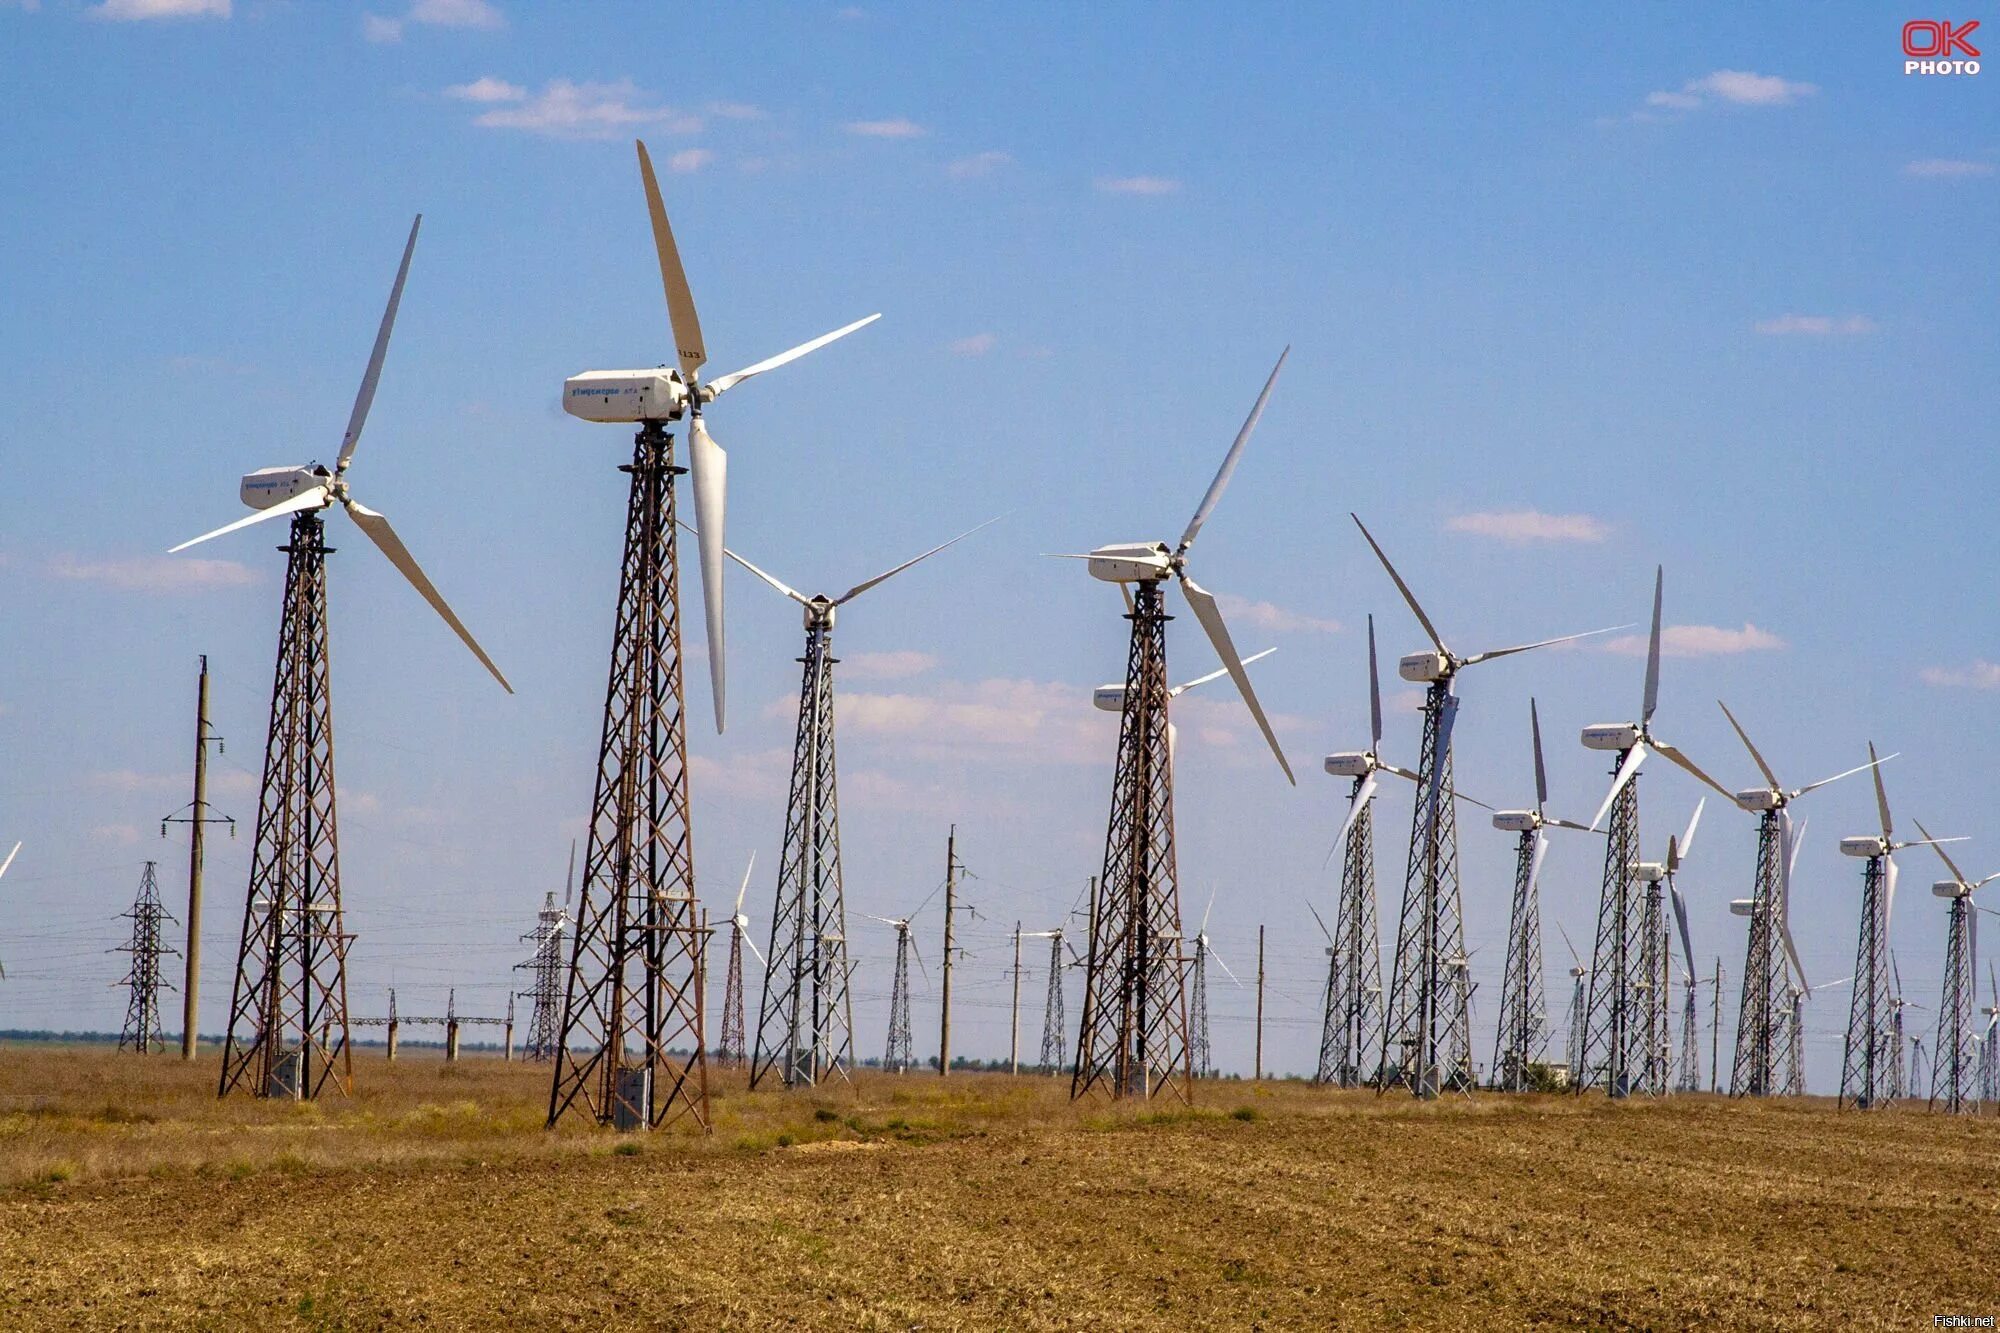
[168,214,514,1101]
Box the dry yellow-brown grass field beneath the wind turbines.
[0,1047,2000,1329]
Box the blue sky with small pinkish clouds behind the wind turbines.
[0,0,2000,1089]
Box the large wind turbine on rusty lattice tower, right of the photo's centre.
[1070,352,1294,1101]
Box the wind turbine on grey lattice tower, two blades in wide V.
[724,518,996,1087]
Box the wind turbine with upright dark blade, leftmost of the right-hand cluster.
[1314,614,1416,1087]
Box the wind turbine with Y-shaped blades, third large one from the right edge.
[1682,701,1896,1097]
